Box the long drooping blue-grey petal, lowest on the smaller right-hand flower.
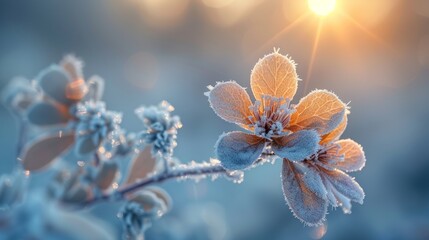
[282,160,328,226]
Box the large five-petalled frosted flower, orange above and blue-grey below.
[206,51,346,170]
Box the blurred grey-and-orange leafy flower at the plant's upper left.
[27,55,88,126]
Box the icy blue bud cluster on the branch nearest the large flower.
[135,101,182,155]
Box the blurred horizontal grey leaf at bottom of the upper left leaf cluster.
[27,102,69,126]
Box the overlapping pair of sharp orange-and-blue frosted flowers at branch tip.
[206,51,365,225]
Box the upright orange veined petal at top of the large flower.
[250,52,298,100]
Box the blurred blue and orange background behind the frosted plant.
[0,0,429,239]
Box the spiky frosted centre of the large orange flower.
[249,95,293,139]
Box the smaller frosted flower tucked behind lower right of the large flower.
[282,114,366,225]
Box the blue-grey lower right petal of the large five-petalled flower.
[271,130,320,161]
